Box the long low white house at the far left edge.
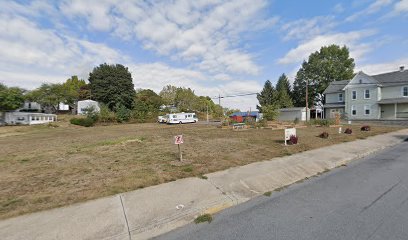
[1,112,57,125]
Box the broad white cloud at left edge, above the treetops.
[0,12,128,88]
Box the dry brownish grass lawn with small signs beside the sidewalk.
[0,122,398,219]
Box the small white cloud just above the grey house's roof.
[356,58,408,75]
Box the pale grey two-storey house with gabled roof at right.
[323,67,408,120]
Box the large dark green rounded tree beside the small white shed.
[89,63,135,109]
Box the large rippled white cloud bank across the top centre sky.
[62,0,278,74]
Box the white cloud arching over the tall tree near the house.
[278,30,374,64]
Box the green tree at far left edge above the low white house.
[0,83,24,111]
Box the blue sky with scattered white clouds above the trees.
[0,0,408,111]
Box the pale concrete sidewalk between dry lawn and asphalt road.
[0,129,408,240]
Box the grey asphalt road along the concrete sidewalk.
[158,142,408,240]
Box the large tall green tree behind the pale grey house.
[293,45,355,106]
